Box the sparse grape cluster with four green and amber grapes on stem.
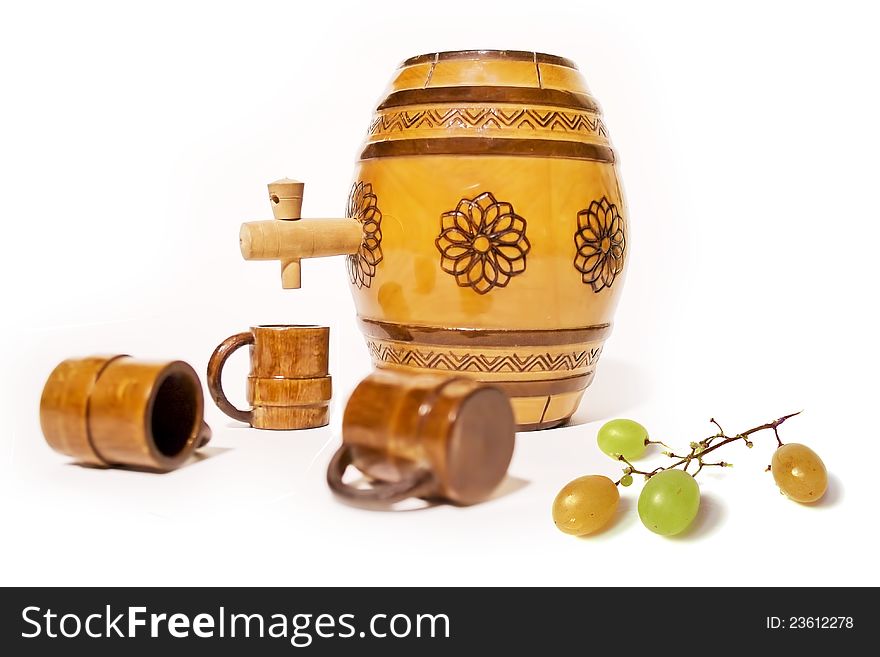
[553,413,828,536]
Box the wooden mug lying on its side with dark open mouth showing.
[40,355,211,472]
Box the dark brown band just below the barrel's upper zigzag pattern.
[360,137,614,163]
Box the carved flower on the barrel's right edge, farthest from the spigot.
[574,196,626,292]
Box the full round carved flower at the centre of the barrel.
[434,192,531,294]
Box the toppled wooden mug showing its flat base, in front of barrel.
[327,370,516,506]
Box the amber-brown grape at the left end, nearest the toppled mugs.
[553,475,620,536]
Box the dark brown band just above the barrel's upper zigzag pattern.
[378,86,599,112]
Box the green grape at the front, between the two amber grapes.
[639,469,700,536]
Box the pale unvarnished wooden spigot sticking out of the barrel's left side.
[239,178,364,290]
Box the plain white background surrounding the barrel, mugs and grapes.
[0,0,880,584]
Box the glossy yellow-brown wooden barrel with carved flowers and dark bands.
[348,51,629,430]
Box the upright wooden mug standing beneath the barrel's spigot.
[208,324,333,430]
